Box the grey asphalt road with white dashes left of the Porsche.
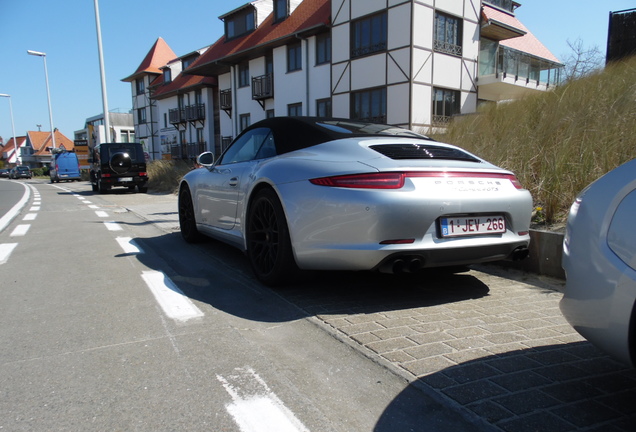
[0,180,482,431]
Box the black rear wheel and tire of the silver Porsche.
[246,189,298,286]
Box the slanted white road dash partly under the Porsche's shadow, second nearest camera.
[141,271,203,321]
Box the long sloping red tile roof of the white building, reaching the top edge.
[187,0,331,75]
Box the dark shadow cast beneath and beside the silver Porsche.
[129,233,488,322]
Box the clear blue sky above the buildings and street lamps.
[0,0,636,140]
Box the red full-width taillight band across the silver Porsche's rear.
[309,171,523,189]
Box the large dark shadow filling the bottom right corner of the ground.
[376,342,636,432]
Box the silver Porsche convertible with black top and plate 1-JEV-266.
[178,117,532,285]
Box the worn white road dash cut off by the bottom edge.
[216,368,309,432]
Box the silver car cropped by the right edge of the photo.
[560,160,636,367]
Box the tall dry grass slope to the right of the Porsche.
[434,57,636,224]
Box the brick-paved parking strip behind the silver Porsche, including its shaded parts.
[279,266,636,432]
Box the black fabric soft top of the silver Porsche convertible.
[239,117,433,155]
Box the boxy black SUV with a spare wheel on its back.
[88,143,148,193]
